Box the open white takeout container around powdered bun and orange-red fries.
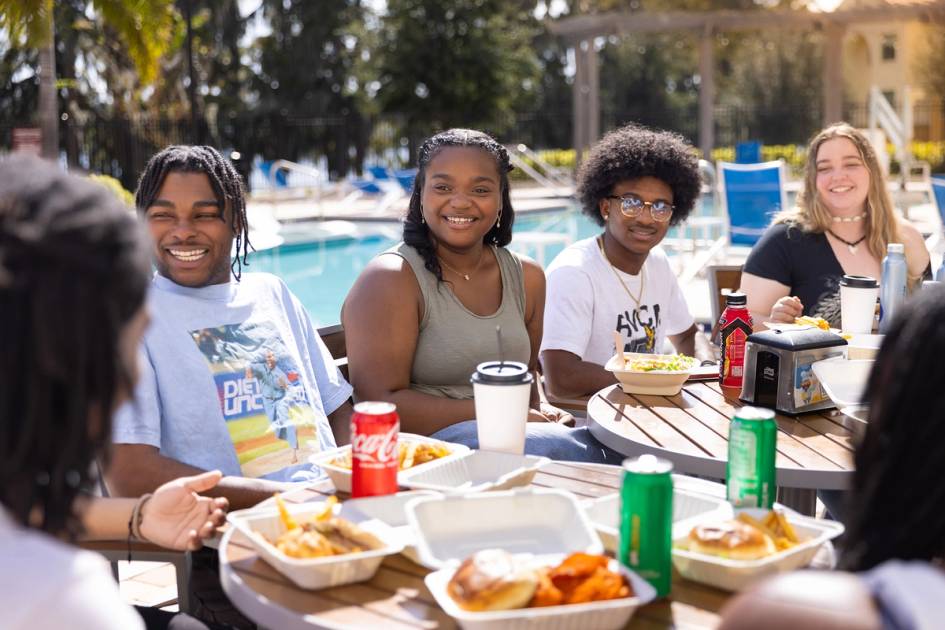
[407,488,656,630]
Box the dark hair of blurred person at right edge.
[841,287,945,571]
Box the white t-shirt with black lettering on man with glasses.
[541,237,694,365]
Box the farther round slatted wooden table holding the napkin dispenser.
[587,381,862,515]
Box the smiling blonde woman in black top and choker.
[741,123,931,328]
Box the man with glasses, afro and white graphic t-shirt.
[541,125,714,398]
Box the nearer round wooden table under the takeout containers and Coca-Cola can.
[220,462,729,630]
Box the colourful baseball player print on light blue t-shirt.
[190,322,319,477]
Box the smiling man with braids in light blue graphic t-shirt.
[110,146,351,508]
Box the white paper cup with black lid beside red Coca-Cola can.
[469,361,534,455]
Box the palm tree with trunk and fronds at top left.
[0,0,179,159]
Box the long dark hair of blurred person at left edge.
[0,156,150,536]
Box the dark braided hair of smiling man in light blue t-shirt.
[135,145,252,280]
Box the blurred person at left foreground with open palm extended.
[0,156,227,630]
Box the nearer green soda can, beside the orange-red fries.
[620,455,673,597]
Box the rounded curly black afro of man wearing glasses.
[577,124,702,226]
